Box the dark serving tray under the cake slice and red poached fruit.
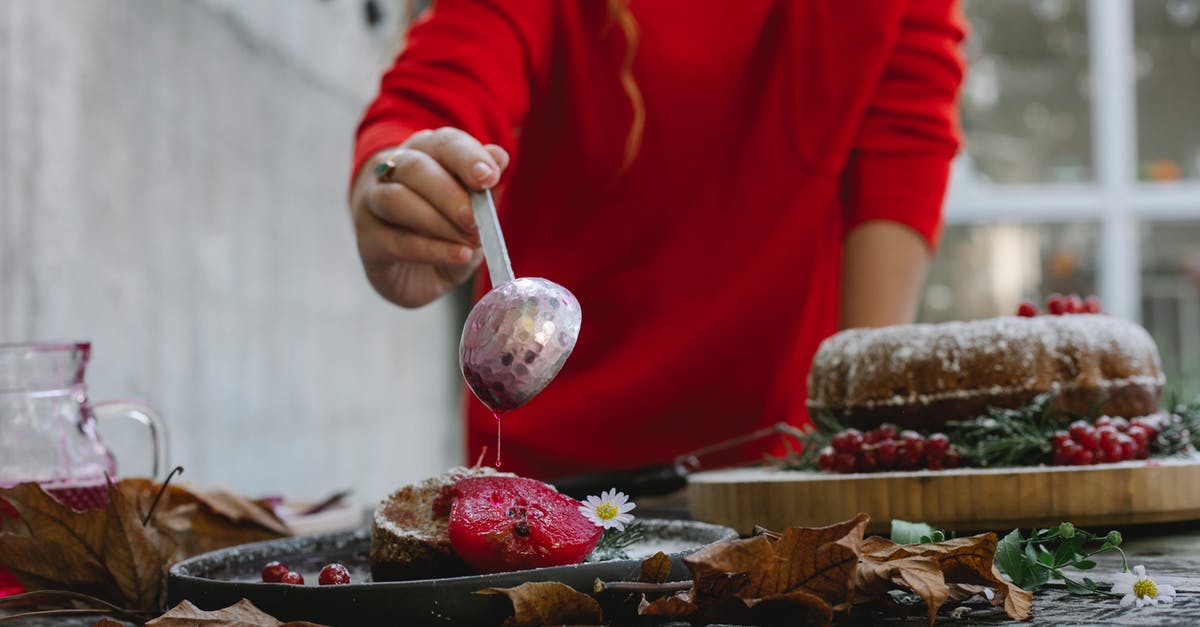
[167,519,737,626]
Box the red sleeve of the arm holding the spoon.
[350,0,554,183]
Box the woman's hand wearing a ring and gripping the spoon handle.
[350,127,509,307]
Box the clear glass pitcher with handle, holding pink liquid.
[0,342,166,510]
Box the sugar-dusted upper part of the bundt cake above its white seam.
[809,315,1164,407]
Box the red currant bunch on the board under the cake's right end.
[1050,416,1160,466]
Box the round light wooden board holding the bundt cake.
[688,459,1200,535]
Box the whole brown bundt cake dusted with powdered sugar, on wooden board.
[808,314,1164,430]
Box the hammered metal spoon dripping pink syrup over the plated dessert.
[458,191,582,414]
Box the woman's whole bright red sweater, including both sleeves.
[355,0,964,478]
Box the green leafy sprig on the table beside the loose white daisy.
[996,523,1129,595]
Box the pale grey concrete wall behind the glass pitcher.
[0,0,461,502]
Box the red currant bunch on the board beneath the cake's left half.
[817,423,962,473]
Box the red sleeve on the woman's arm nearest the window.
[845,0,965,249]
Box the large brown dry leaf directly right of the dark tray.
[640,514,868,622]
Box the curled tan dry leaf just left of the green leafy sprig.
[856,533,1033,625]
